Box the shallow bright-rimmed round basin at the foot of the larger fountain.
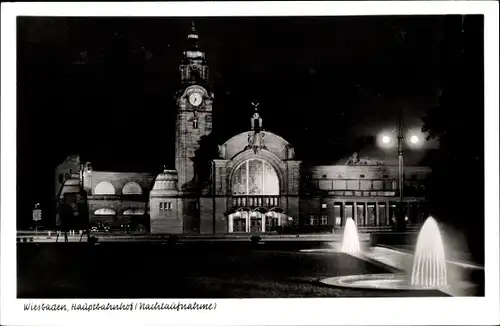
[320,273,474,293]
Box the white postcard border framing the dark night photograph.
[0,1,500,325]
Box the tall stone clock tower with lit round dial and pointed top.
[175,23,213,197]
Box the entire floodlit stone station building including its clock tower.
[55,27,431,234]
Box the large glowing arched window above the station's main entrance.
[231,159,280,196]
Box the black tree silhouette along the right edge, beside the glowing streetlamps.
[422,16,484,261]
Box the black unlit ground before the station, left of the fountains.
[17,243,445,298]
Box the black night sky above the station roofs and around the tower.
[17,16,482,227]
